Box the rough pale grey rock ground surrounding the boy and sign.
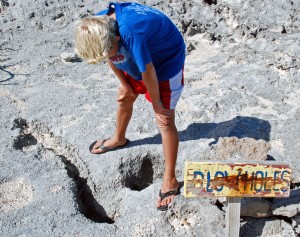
[0,0,300,237]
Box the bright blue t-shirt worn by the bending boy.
[97,2,185,81]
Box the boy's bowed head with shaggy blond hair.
[75,15,119,63]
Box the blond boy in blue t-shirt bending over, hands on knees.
[75,2,185,210]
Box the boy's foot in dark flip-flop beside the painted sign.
[156,179,179,210]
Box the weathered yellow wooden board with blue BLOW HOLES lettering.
[184,161,291,198]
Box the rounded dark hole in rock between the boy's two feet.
[123,157,154,191]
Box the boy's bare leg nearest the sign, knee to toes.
[156,110,179,207]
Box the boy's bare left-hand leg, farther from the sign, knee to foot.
[92,87,138,153]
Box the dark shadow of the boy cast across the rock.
[129,116,271,147]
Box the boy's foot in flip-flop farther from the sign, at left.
[90,138,128,154]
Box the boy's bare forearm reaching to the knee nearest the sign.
[142,62,172,124]
